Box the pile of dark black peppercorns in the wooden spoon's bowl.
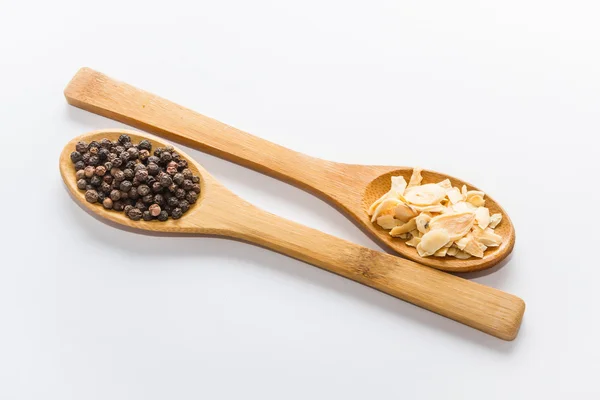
[71,135,200,221]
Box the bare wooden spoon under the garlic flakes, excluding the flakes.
[65,68,515,272]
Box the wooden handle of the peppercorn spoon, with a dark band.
[217,207,525,340]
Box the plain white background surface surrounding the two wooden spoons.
[0,0,600,400]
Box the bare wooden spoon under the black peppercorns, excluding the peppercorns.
[60,130,525,340]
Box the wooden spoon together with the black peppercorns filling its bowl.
[60,130,525,340]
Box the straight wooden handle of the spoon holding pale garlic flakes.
[65,68,339,194]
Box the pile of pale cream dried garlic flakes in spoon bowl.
[369,168,502,260]
